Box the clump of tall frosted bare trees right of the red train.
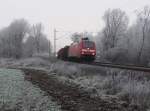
[97,6,150,65]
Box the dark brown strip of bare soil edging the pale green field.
[22,69,139,111]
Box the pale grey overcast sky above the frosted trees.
[0,0,150,50]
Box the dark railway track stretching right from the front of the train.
[77,62,150,72]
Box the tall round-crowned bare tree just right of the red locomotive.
[103,9,128,50]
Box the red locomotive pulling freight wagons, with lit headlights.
[57,38,96,61]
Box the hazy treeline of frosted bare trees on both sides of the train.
[0,6,150,65]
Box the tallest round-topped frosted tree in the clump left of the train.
[8,19,29,58]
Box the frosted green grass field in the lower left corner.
[0,69,60,111]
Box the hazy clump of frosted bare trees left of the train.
[0,19,50,58]
